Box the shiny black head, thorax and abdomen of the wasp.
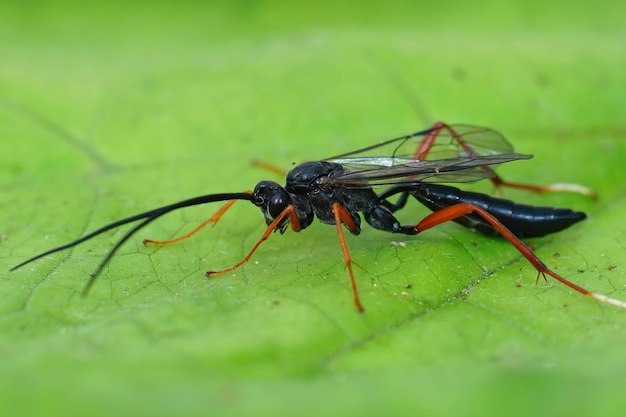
[253,161,586,237]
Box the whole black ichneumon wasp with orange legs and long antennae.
[11,123,626,312]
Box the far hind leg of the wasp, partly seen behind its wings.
[414,122,598,200]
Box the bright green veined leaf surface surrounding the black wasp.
[0,1,626,416]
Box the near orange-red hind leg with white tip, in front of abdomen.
[413,203,626,308]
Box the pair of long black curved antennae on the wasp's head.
[10,192,254,278]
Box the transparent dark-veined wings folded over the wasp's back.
[325,125,532,187]
